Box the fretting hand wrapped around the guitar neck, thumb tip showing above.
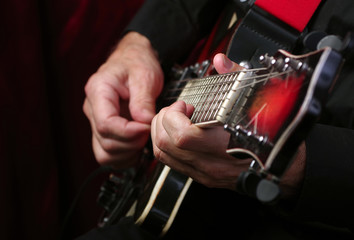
[151,54,251,190]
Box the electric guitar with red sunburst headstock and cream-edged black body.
[95,9,342,240]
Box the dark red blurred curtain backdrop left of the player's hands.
[0,0,143,240]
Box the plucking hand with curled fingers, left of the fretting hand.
[83,32,163,167]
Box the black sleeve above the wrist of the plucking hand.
[126,0,226,62]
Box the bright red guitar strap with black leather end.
[228,0,321,68]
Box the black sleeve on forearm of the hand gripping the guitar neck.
[295,124,354,227]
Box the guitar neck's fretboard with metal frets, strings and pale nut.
[172,69,279,127]
